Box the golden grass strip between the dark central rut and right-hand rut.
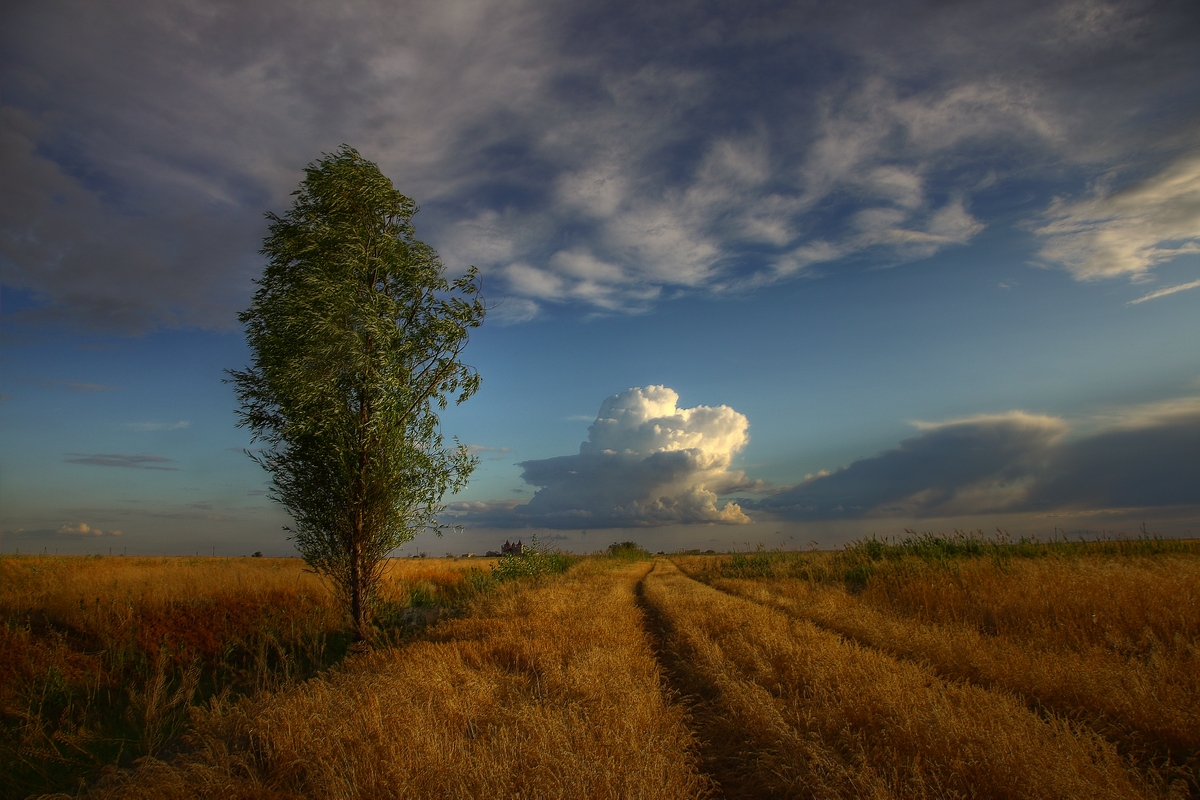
[644,561,1144,798]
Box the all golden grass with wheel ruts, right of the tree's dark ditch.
[11,558,1198,798]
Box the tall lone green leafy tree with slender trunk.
[229,145,486,640]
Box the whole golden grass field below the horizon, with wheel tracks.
[0,535,1200,798]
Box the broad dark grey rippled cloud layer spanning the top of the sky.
[0,0,1200,332]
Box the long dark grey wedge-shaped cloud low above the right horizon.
[742,398,1200,519]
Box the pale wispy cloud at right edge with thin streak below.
[1036,154,1200,281]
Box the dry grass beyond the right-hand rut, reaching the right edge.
[685,555,1200,787]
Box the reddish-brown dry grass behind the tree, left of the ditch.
[0,557,486,798]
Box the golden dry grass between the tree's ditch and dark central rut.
[77,564,707,799]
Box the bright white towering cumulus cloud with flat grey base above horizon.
[450,386,761,528]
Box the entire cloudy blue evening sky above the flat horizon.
[0,0,1200,555]
